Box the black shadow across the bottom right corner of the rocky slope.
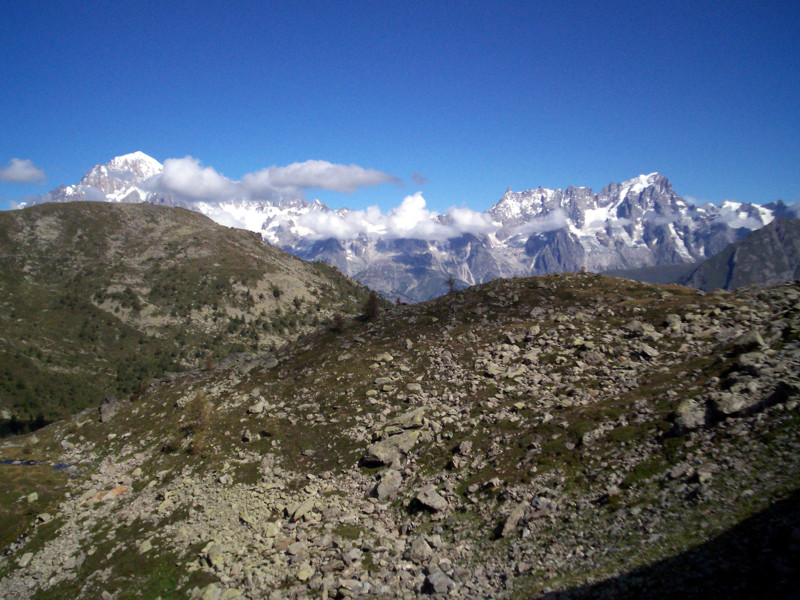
[542,490,800,600]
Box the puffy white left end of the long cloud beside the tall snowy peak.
[142,156,237,202]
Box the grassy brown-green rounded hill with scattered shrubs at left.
[0,202,374,421]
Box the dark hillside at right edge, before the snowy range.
[679,218,800,291]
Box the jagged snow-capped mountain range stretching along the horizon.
[17,152,797,301]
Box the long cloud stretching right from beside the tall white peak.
[142,156,400,203]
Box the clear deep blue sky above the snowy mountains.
[0,0,800,212]
